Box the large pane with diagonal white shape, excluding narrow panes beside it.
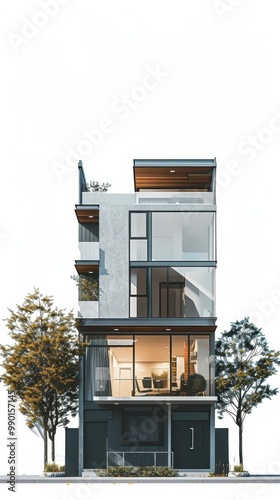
[152,267,215,318]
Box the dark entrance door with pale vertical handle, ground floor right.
[172,420,210,469]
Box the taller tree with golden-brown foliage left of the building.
[0,288,83,465]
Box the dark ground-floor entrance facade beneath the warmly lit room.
[80,404,211,470]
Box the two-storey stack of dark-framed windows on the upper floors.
[130,212,216,318]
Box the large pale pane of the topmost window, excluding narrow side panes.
[152,212,215,261]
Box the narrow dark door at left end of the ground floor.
[84,422,107,469]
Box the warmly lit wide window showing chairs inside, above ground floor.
[84,334,211,401]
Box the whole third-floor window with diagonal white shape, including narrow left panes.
[130,266,215,318]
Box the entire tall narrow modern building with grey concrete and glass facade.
[75,158,217,475]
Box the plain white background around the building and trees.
[0,0,280,494]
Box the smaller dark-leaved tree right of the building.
[216,317,280,464]
